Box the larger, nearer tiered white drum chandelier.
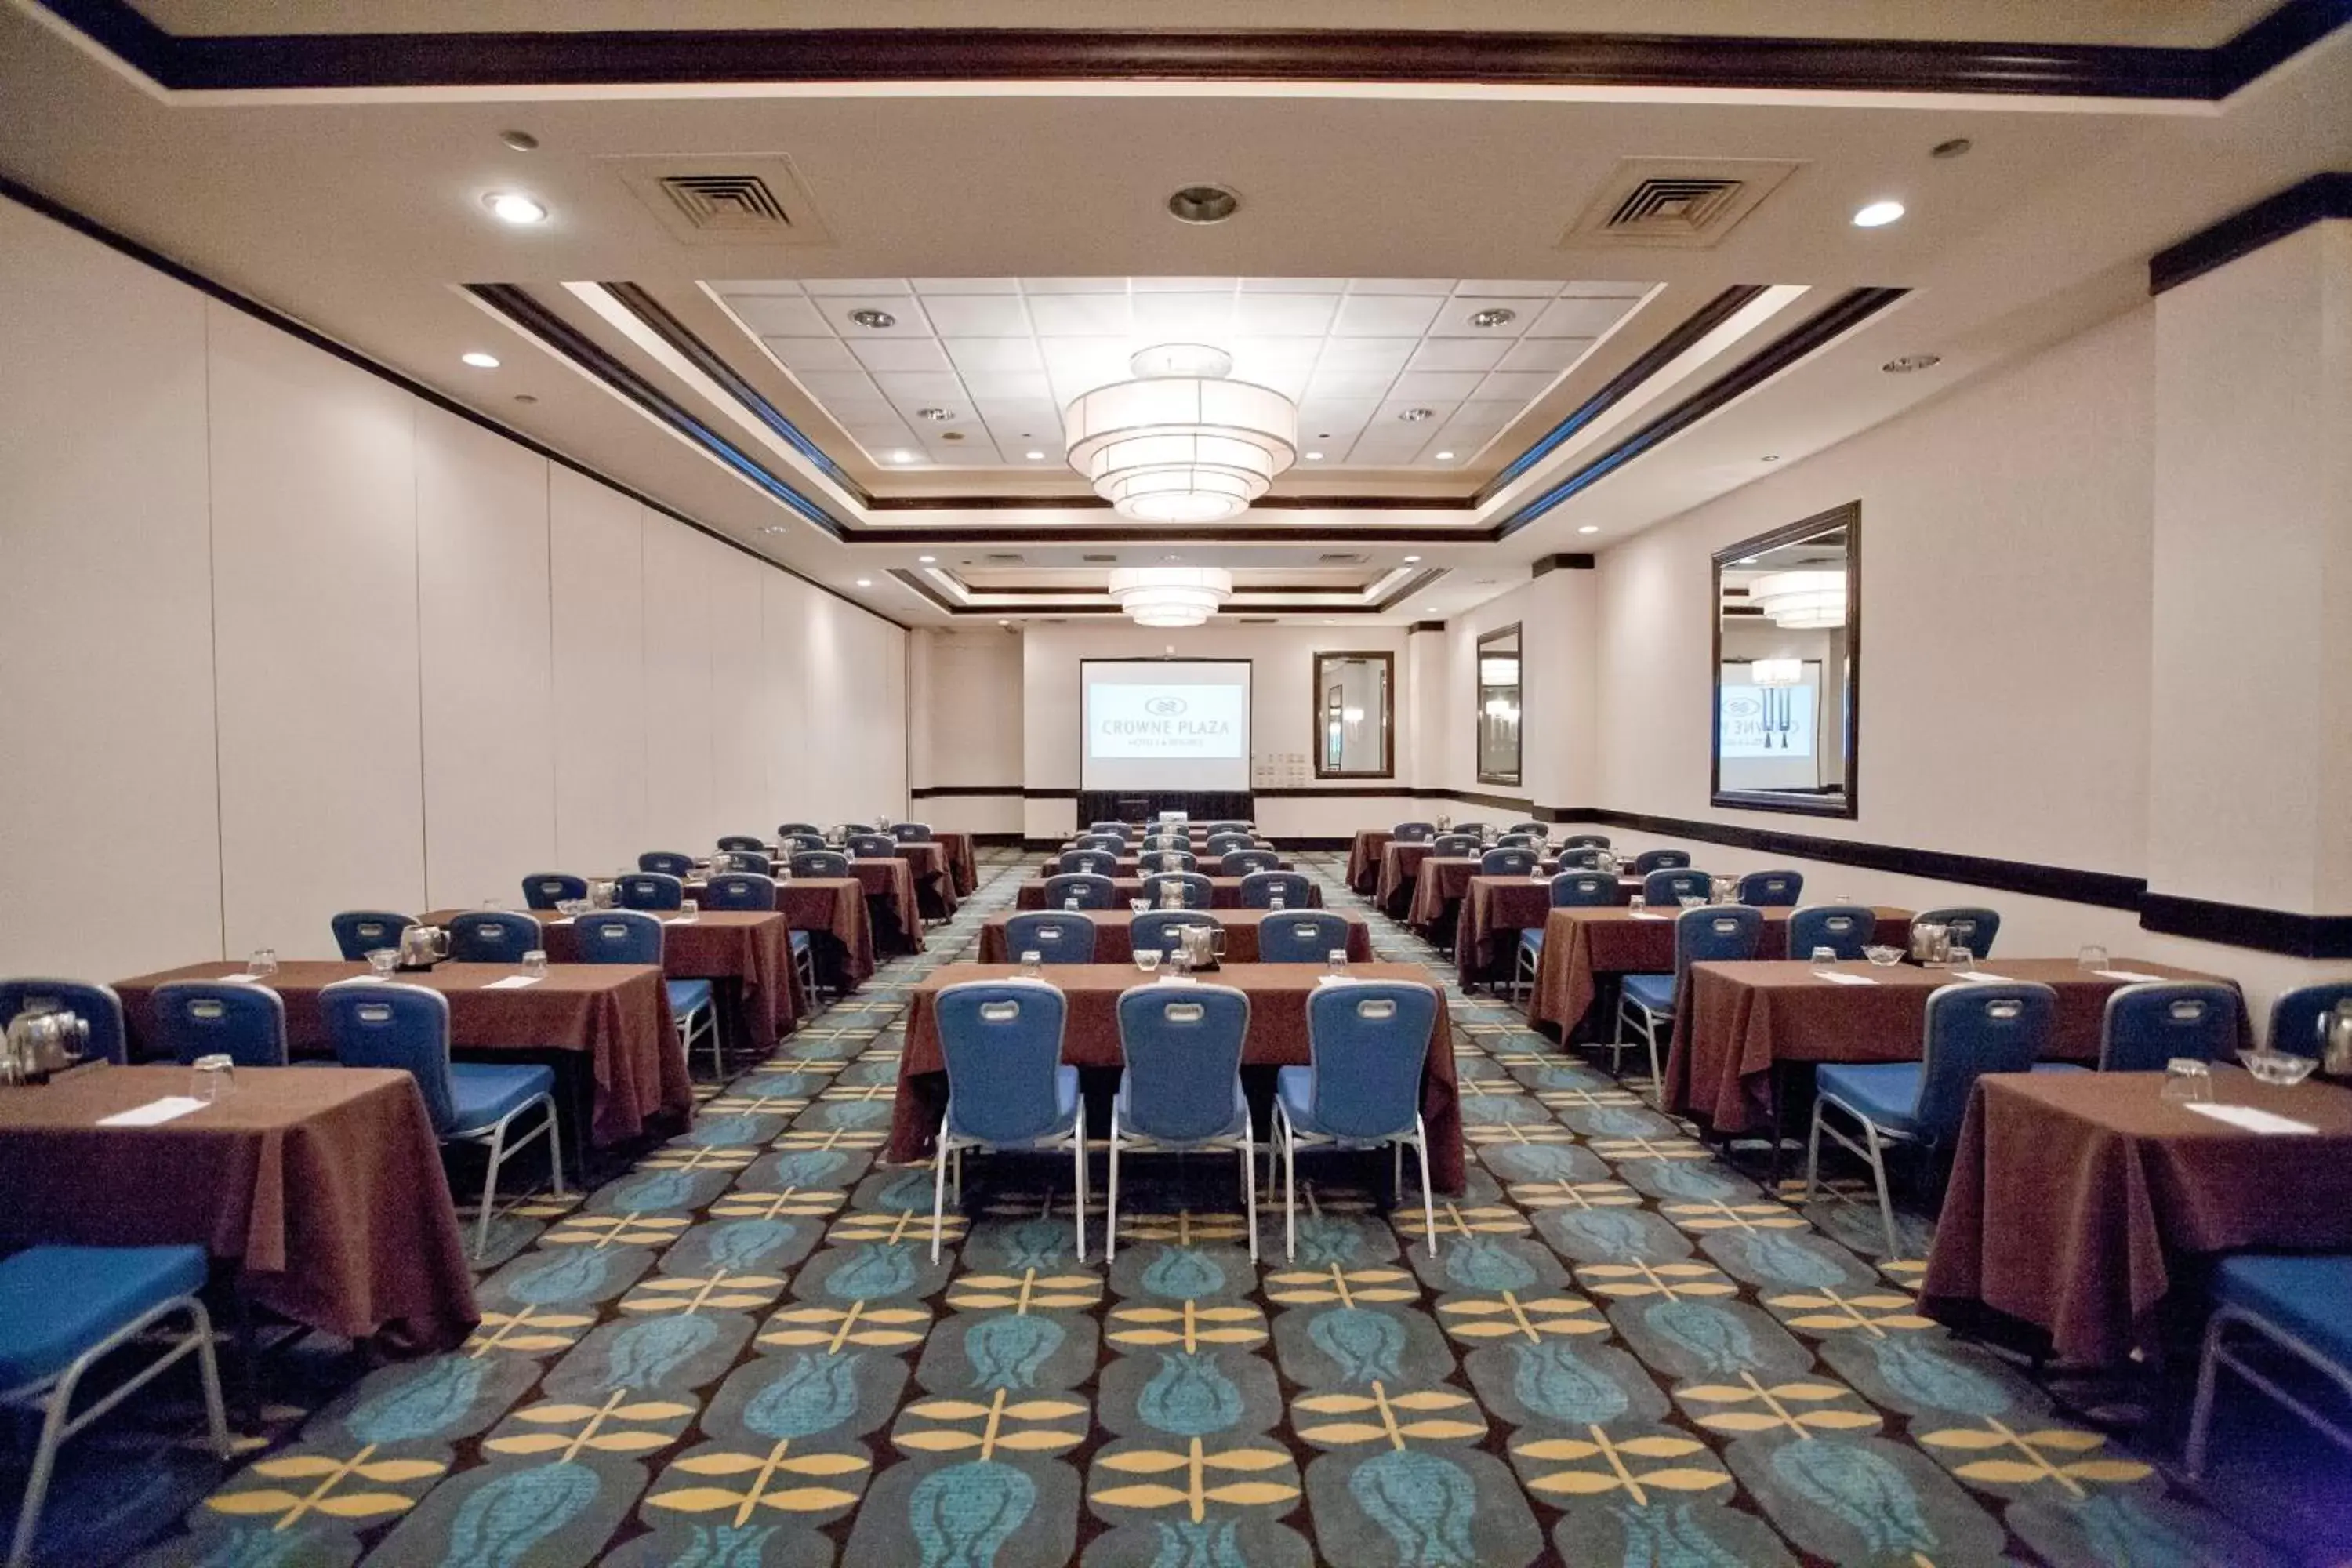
[1061,343,1298,522]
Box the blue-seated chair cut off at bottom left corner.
[0,1246,233,1568]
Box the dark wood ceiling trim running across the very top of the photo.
[40,0,2343,101]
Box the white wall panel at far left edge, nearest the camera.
[0,205,221,978]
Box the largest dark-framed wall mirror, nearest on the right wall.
[1710,501,1863,815]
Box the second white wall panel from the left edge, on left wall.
[207,303,426,954]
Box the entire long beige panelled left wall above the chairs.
[0,202,906,978]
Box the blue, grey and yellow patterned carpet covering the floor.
[13,851,2333,1568]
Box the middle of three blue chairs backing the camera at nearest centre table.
[1103,992,1258,1262]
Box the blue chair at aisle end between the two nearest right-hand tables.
[1804,980,2058,1258]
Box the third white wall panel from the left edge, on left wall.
[416,407,555,907]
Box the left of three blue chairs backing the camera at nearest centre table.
[931,980,1091,1262]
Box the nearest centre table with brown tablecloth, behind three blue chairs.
[889,964,1463,1192]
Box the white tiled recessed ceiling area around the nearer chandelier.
[703,278,1653,473]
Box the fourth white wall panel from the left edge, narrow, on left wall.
[553,463,652,874]
